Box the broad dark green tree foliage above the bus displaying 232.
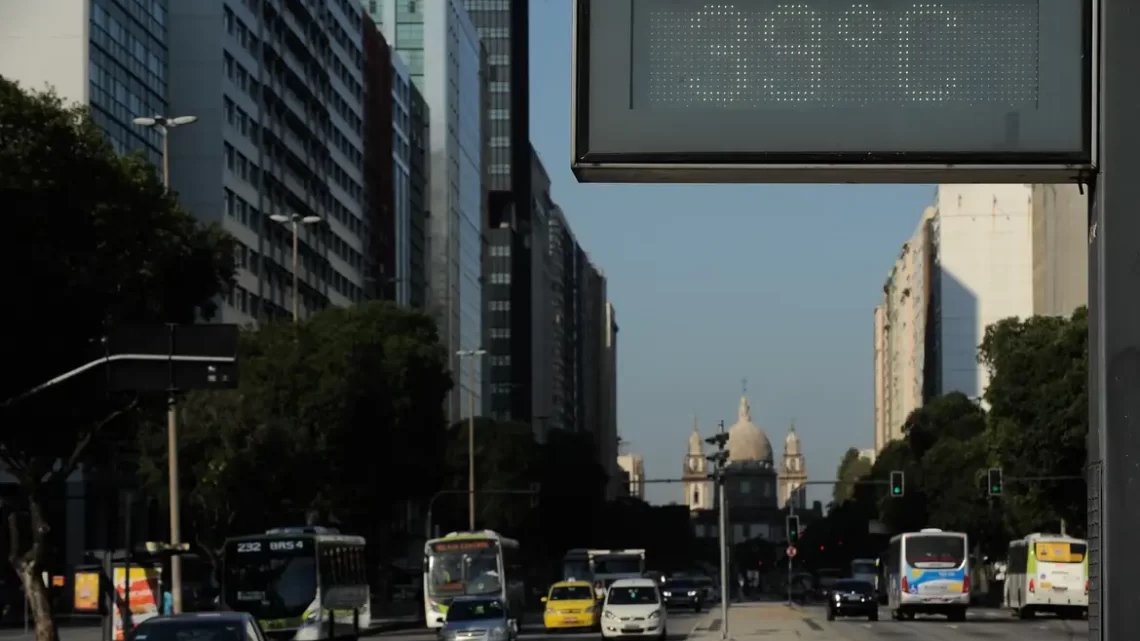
[141,302,451,561]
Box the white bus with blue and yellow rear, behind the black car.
[887,528,970,622]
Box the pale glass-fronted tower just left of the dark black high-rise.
[364,0,487,421]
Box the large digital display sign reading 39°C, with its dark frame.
[571,0,1097,184]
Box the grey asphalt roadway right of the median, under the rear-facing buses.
[793,606,1089,641]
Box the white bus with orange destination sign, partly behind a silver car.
[424,529,527,628]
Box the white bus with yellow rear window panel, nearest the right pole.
[1002,533,1089,618]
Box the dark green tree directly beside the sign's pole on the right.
[978,307,1089,535]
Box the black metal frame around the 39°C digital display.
[570,0,1099,185]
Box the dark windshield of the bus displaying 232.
[223,543,317,619]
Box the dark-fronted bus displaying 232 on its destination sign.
[221,526,372,641]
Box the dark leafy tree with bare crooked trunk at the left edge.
[0,78,234,641]
